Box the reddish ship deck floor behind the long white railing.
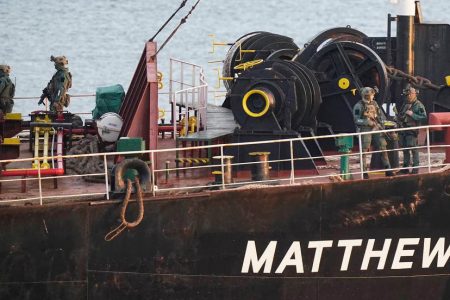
[0,107,447,205]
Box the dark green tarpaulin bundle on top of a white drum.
[92,84,125,119]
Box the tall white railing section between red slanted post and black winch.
[169,58,208,138]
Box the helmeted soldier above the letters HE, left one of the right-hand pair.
[353,87,393,179]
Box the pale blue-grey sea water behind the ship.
[0,0,450,113]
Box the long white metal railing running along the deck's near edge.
[0,125,450,205]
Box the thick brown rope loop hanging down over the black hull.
[105,178,144,242]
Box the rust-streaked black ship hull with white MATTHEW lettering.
[0,173,450,300]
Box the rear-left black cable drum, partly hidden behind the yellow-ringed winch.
[222,31,298,90]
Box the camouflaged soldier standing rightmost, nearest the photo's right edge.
[398,86,427,174]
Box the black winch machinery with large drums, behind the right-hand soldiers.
[223,2,450,168]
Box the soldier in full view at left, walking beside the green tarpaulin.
[38,56,72,112]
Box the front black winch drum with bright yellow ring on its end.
[230,61,320,132]
